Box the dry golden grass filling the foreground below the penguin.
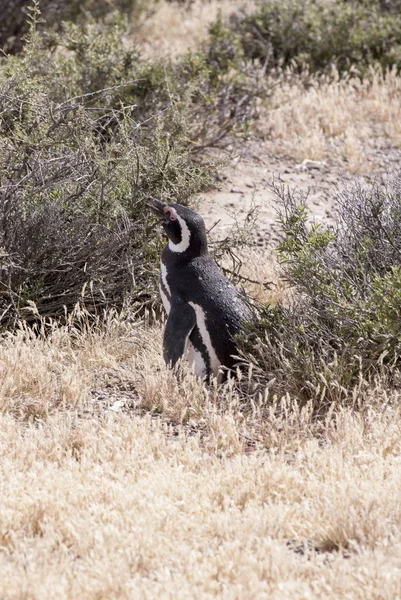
[0,308,401,600]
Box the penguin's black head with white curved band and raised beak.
[148,198,207,256]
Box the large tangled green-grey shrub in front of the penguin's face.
[0,6,252,325]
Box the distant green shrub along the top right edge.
[211,0,401,73]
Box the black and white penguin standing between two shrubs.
[148,198,251,380]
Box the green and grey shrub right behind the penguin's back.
[241,179,401,408]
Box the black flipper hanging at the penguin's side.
[163,298,196,367]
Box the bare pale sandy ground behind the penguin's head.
[199,140,401,245]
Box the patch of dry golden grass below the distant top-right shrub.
[257,71,401,173]
